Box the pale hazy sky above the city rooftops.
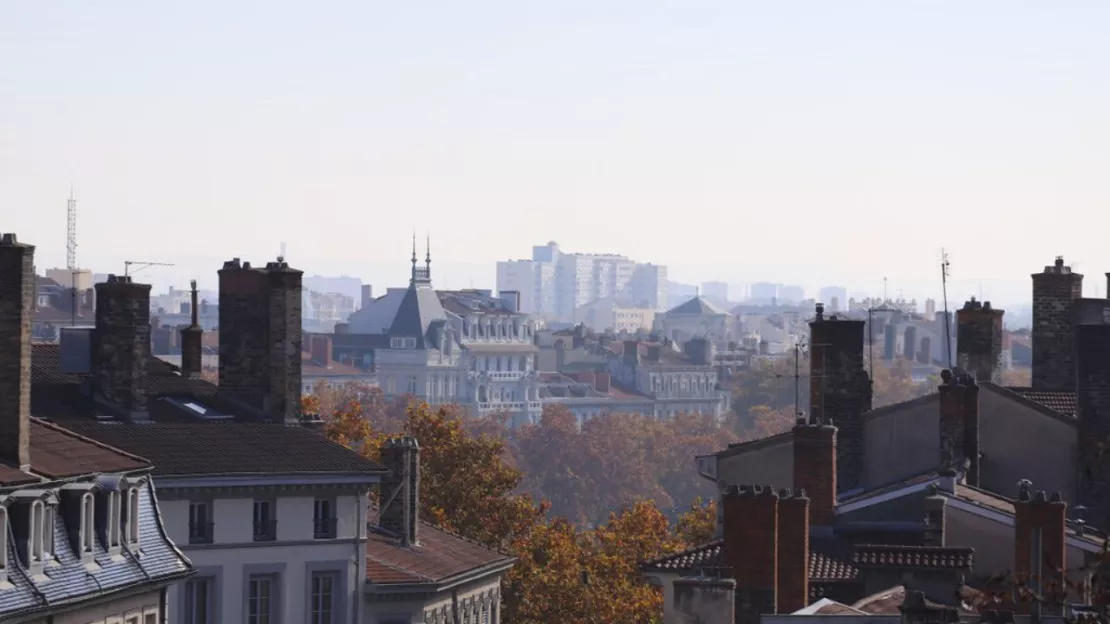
[0,0,1110,301]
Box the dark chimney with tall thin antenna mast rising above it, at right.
[937,370,979,486]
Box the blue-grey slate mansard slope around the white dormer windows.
[0,480,193,622]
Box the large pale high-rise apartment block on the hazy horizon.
[497,241,667,322]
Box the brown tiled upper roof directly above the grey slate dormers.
[0,419,150,486]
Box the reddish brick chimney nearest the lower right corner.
[1013,481,1068,613]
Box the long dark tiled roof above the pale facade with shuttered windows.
[54,420,386,476]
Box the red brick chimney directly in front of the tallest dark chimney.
[794,419,837,524]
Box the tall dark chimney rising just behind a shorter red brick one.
[809,303,871,490]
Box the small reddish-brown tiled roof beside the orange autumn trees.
[366,522,516,585]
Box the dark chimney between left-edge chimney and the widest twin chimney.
[92,275,150,420]
